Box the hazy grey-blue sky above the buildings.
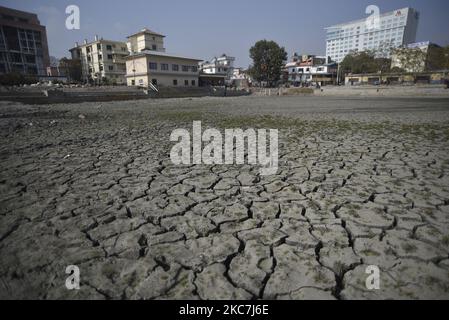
[0,0,449,67]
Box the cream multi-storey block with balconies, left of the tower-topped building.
[70,36,129,84]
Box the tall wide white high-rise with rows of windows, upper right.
[326,8,419,62]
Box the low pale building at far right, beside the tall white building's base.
[391,41,441,72]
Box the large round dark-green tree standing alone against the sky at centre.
[249,40,287,86]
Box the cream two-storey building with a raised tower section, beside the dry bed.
[125,29,202,87]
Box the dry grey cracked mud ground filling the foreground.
[0,97,449,299]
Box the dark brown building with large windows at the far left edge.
[0,7,50,75]
